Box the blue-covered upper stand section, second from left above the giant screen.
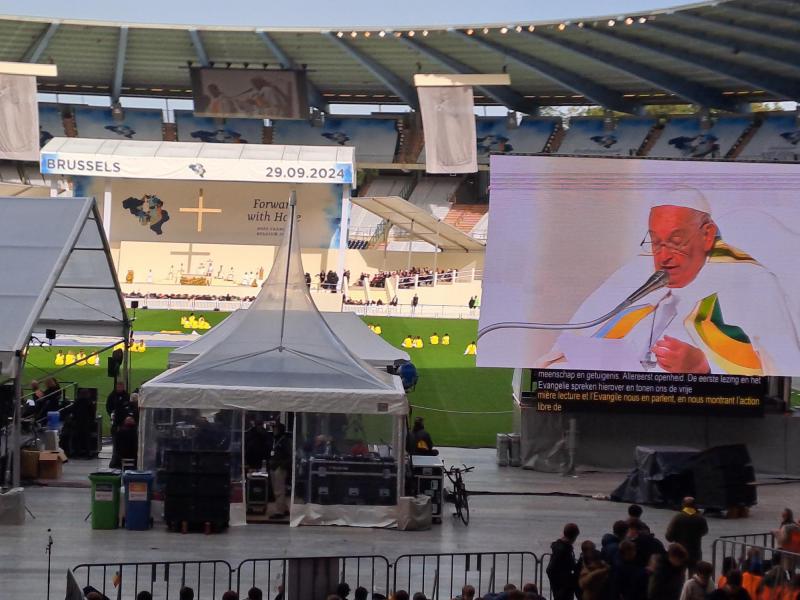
[558,117,656,156]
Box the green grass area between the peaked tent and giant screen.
[364,317,513,447]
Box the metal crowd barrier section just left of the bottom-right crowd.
[392,552,543,600]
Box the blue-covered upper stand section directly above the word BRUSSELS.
[73,106,163,141]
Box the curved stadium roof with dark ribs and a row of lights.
[0,0,800,112]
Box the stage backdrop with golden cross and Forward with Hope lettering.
[75,178,341,248]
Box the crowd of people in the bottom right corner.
[546,497,800,600]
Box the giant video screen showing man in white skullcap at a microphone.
[478,156,800,380]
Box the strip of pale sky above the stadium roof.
[0,0,687,28]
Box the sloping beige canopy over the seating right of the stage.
[350,196,486,252]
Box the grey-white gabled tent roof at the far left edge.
[0,197,129,378]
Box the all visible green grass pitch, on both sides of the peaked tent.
[25,309,512,447]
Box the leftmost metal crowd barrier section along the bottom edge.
[72,560,234,600]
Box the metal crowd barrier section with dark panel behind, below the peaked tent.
[236,555,391,598]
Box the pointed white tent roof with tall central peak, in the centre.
[139,199,408,415]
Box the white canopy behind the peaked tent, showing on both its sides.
[169,309,409,368]
